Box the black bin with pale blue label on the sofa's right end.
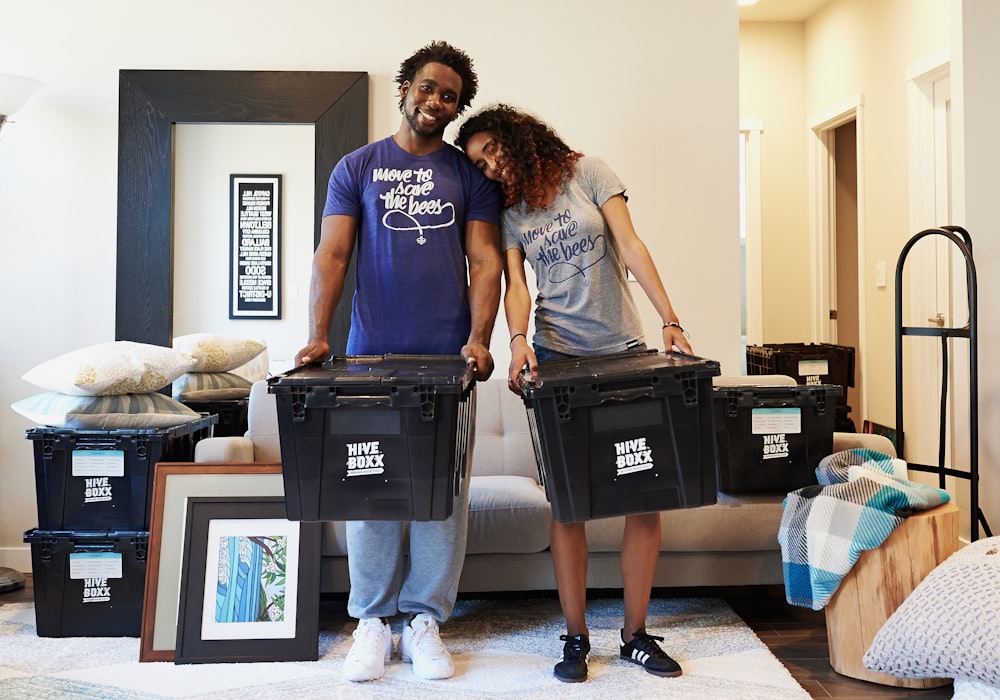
[713,384,841,493]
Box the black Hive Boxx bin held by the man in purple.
[268,355,475,520]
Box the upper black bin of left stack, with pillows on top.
[26,416,217,531]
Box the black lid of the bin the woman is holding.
[520,350,721,393]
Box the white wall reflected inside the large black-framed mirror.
[174,124,314,372]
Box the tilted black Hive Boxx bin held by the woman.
[521,350,719,523]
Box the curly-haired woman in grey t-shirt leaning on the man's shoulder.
[456,104,691,682]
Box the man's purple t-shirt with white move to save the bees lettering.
[323,137,501,355]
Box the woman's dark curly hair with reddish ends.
[455,104,583,211]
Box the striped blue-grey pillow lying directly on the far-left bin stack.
[11,391,201,430]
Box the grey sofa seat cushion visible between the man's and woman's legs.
[467,475,551,554]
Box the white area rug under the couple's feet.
[0,598,809,700]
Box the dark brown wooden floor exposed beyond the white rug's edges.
[0,575,952,700]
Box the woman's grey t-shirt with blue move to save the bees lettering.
[502,157,645,355]
